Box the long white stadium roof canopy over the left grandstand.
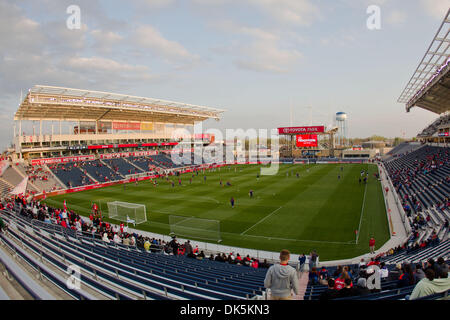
[14,85,224,124]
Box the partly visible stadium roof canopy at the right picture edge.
[398,9,450,114]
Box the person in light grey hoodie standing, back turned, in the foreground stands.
[264,250,299,300]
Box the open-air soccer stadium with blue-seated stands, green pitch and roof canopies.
[0,0,450,301]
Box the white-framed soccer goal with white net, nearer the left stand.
[107,201,147,225]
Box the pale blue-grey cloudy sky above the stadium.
[0,0,450,149]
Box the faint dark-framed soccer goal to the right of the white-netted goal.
[169,215,222,242]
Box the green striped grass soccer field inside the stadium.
[45,164,389,261]
